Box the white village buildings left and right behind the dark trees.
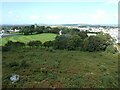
[0,24,120,43]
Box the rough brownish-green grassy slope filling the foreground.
[3,48,118,88]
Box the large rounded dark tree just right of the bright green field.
[54,34,82,50]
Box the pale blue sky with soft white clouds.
[0,0,118,24]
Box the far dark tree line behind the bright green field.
[20,25,90,35]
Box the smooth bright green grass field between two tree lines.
[0,33,56,46]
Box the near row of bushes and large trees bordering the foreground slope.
[3,29,117,53]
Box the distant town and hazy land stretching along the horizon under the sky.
[0,24,120,43]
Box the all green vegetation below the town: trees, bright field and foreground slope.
[2,25,118,88]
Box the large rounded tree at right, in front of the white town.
[83,34,112,52]
